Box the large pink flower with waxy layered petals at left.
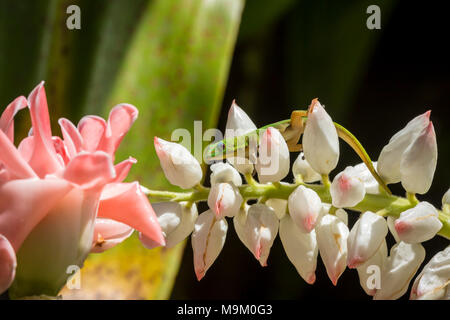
[0,82,165,297]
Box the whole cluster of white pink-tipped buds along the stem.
[149,99,450,299]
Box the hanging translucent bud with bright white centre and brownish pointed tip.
[244,203,278,267]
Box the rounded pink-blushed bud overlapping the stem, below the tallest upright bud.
[288,186,322,232]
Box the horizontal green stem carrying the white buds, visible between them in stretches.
[147,180,450,239]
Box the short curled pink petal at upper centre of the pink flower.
[63,151,116,189]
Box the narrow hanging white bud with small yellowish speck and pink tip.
[315,214,349,285]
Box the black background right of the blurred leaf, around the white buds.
[171,0,450,299]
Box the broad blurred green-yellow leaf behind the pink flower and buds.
[59,0,243,299]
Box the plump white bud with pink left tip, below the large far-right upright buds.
[395,201,442,243]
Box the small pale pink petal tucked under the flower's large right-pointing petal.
[91,218,134,253]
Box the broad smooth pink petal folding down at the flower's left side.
[0,178,71,252]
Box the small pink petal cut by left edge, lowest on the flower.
[0,234,17,293]
